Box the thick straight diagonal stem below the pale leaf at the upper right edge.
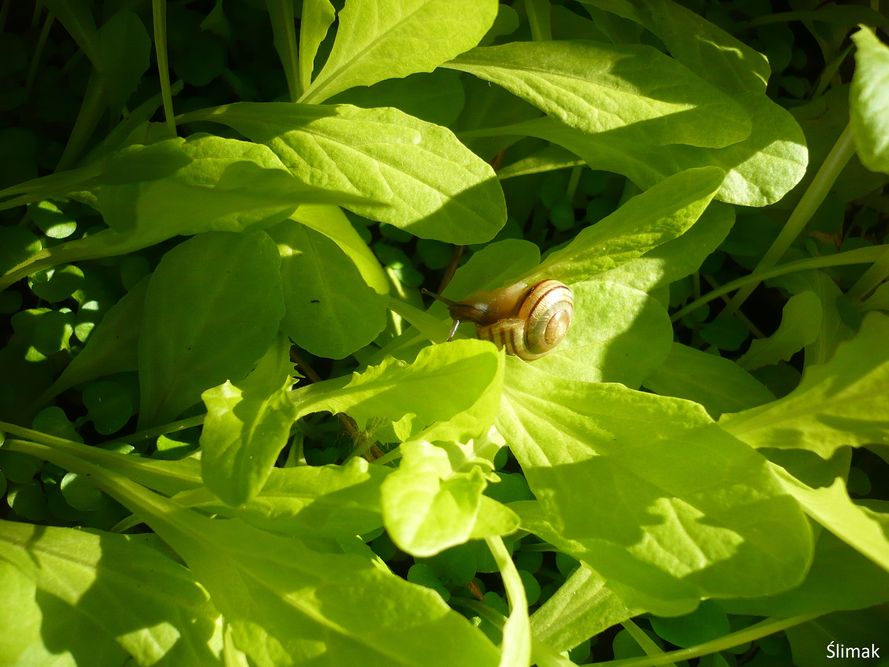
[723,125,855,315]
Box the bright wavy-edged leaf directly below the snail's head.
[293,340,503,441]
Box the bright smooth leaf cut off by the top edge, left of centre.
[300,0,497,103]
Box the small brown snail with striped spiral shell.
[423,280,574,361]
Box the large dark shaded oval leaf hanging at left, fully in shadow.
[139,232,284,425]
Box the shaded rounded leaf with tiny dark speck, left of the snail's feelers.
[269,220,388,359]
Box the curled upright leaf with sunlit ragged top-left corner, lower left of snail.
[200,337,296,507]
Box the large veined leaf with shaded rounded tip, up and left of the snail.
[189,102,506,243]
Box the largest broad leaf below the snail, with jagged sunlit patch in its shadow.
[497,367,812,615]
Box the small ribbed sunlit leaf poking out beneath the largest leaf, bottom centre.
[531,563,644,651]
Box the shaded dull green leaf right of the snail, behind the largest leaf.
[645,343,775,418]
